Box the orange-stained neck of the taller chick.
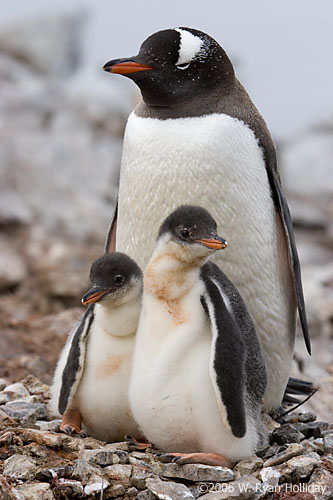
[144,241,206,302]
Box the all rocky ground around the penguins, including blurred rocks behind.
[0,10,333,500]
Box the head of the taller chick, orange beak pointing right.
[157,205,227,263]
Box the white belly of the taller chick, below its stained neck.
[130,296,256,460]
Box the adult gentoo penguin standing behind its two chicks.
[104,28,310,410]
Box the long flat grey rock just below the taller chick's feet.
[152,463,235,482]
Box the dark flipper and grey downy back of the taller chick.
[201,262,267,437]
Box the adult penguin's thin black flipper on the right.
[267,168,311,354]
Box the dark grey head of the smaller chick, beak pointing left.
[81,252,143,306]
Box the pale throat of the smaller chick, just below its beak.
[95,292,141,337]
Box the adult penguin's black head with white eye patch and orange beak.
[103,28,235,106]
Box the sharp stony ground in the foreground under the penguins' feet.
[0,375,333,500]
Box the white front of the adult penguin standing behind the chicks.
[117,113,295,410]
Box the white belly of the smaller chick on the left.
[72,326,138,442]
